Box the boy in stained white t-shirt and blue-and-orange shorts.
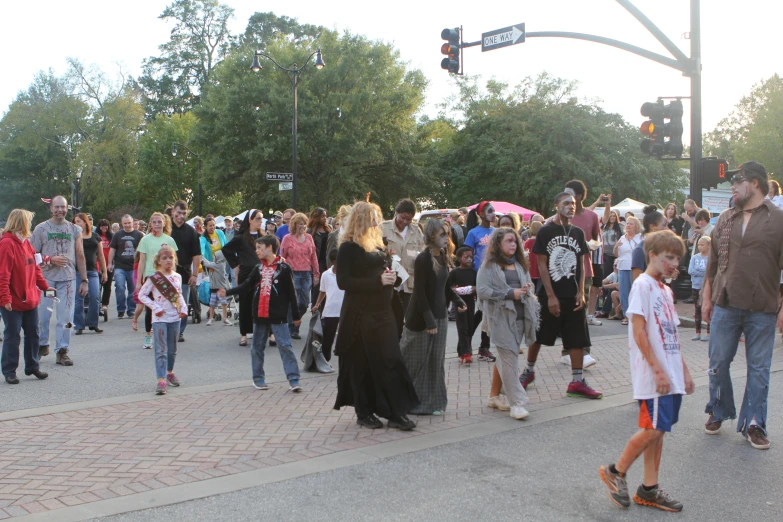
[598,230,694,511]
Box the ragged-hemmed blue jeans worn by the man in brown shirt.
[705,305,777,435]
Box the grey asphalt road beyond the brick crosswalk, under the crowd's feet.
[0,290,627,412]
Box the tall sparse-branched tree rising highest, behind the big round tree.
[138,0,234,118]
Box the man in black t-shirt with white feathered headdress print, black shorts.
[519,192,602,399]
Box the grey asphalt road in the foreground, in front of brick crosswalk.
[105,374,783,522]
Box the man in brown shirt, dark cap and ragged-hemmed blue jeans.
[702,161,783,449]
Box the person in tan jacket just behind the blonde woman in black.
[381,199,424,315]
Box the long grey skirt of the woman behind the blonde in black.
[400,317,449,415]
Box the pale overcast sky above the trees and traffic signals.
[0,0,783,138]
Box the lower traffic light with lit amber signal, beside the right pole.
[639,100,683,157]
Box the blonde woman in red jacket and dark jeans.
[0,209,54,384]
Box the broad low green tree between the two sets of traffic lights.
[437,73,685,213]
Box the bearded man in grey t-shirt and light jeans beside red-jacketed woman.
[30,196,88,366]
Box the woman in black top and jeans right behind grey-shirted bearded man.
[73,213,108,335]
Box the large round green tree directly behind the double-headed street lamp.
[195,21,426,213]
